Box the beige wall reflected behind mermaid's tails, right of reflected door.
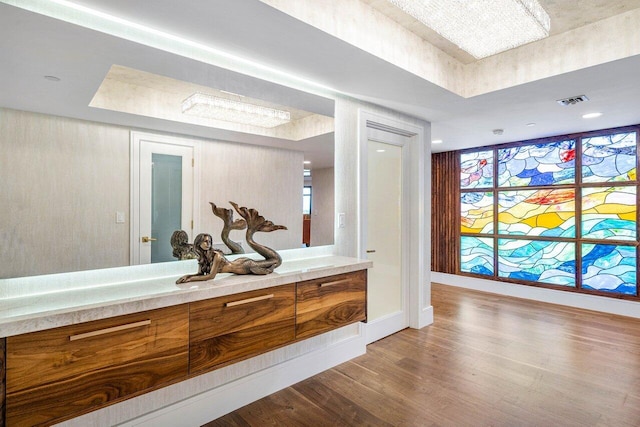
[198,141,304,252]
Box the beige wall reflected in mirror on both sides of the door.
[0,109,303,278]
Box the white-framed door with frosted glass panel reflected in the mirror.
[132,135,195,264]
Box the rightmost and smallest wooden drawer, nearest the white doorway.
[296,270,367,339]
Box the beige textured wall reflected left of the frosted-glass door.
[0,109,129,278]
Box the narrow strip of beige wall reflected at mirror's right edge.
[311,168,336,246]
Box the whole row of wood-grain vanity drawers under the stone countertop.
[0,270,367,427]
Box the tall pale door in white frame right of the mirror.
[365,138,408,342]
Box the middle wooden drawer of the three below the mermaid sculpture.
[189,284,295,374]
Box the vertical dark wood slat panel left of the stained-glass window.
[431,151,460,274]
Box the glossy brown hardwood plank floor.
[206,284,640,427]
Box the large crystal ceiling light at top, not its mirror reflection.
[387,0,551,59]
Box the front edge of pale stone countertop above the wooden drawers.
[0,256,373,338]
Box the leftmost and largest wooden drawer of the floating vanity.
[6,304,189,426]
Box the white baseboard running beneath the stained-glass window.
[431,271,640,318]
